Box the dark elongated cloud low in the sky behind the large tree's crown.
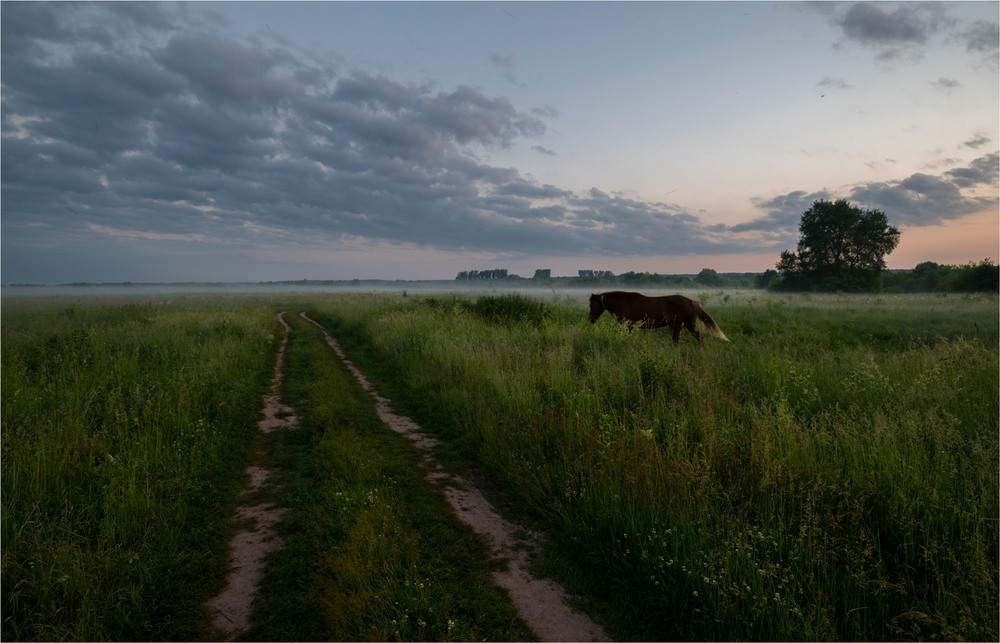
[744,153,1000,238]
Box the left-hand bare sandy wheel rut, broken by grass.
[208,313,298,641]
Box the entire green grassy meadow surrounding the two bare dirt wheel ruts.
[0,291,1000,640]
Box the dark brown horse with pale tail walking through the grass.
[590,290,729,344]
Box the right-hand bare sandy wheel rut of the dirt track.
[300,313,610,641]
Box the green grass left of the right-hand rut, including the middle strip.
[0,296,531,640]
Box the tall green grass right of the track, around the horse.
[314,294,1000,640]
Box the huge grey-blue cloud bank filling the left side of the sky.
[0,3,735,266]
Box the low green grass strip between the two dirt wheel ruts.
[243,304,532,641]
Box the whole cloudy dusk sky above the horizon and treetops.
[0,1,1000,284]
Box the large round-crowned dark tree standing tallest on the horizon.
[777,199,899,291]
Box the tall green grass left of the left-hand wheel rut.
[0,299,276,640]
